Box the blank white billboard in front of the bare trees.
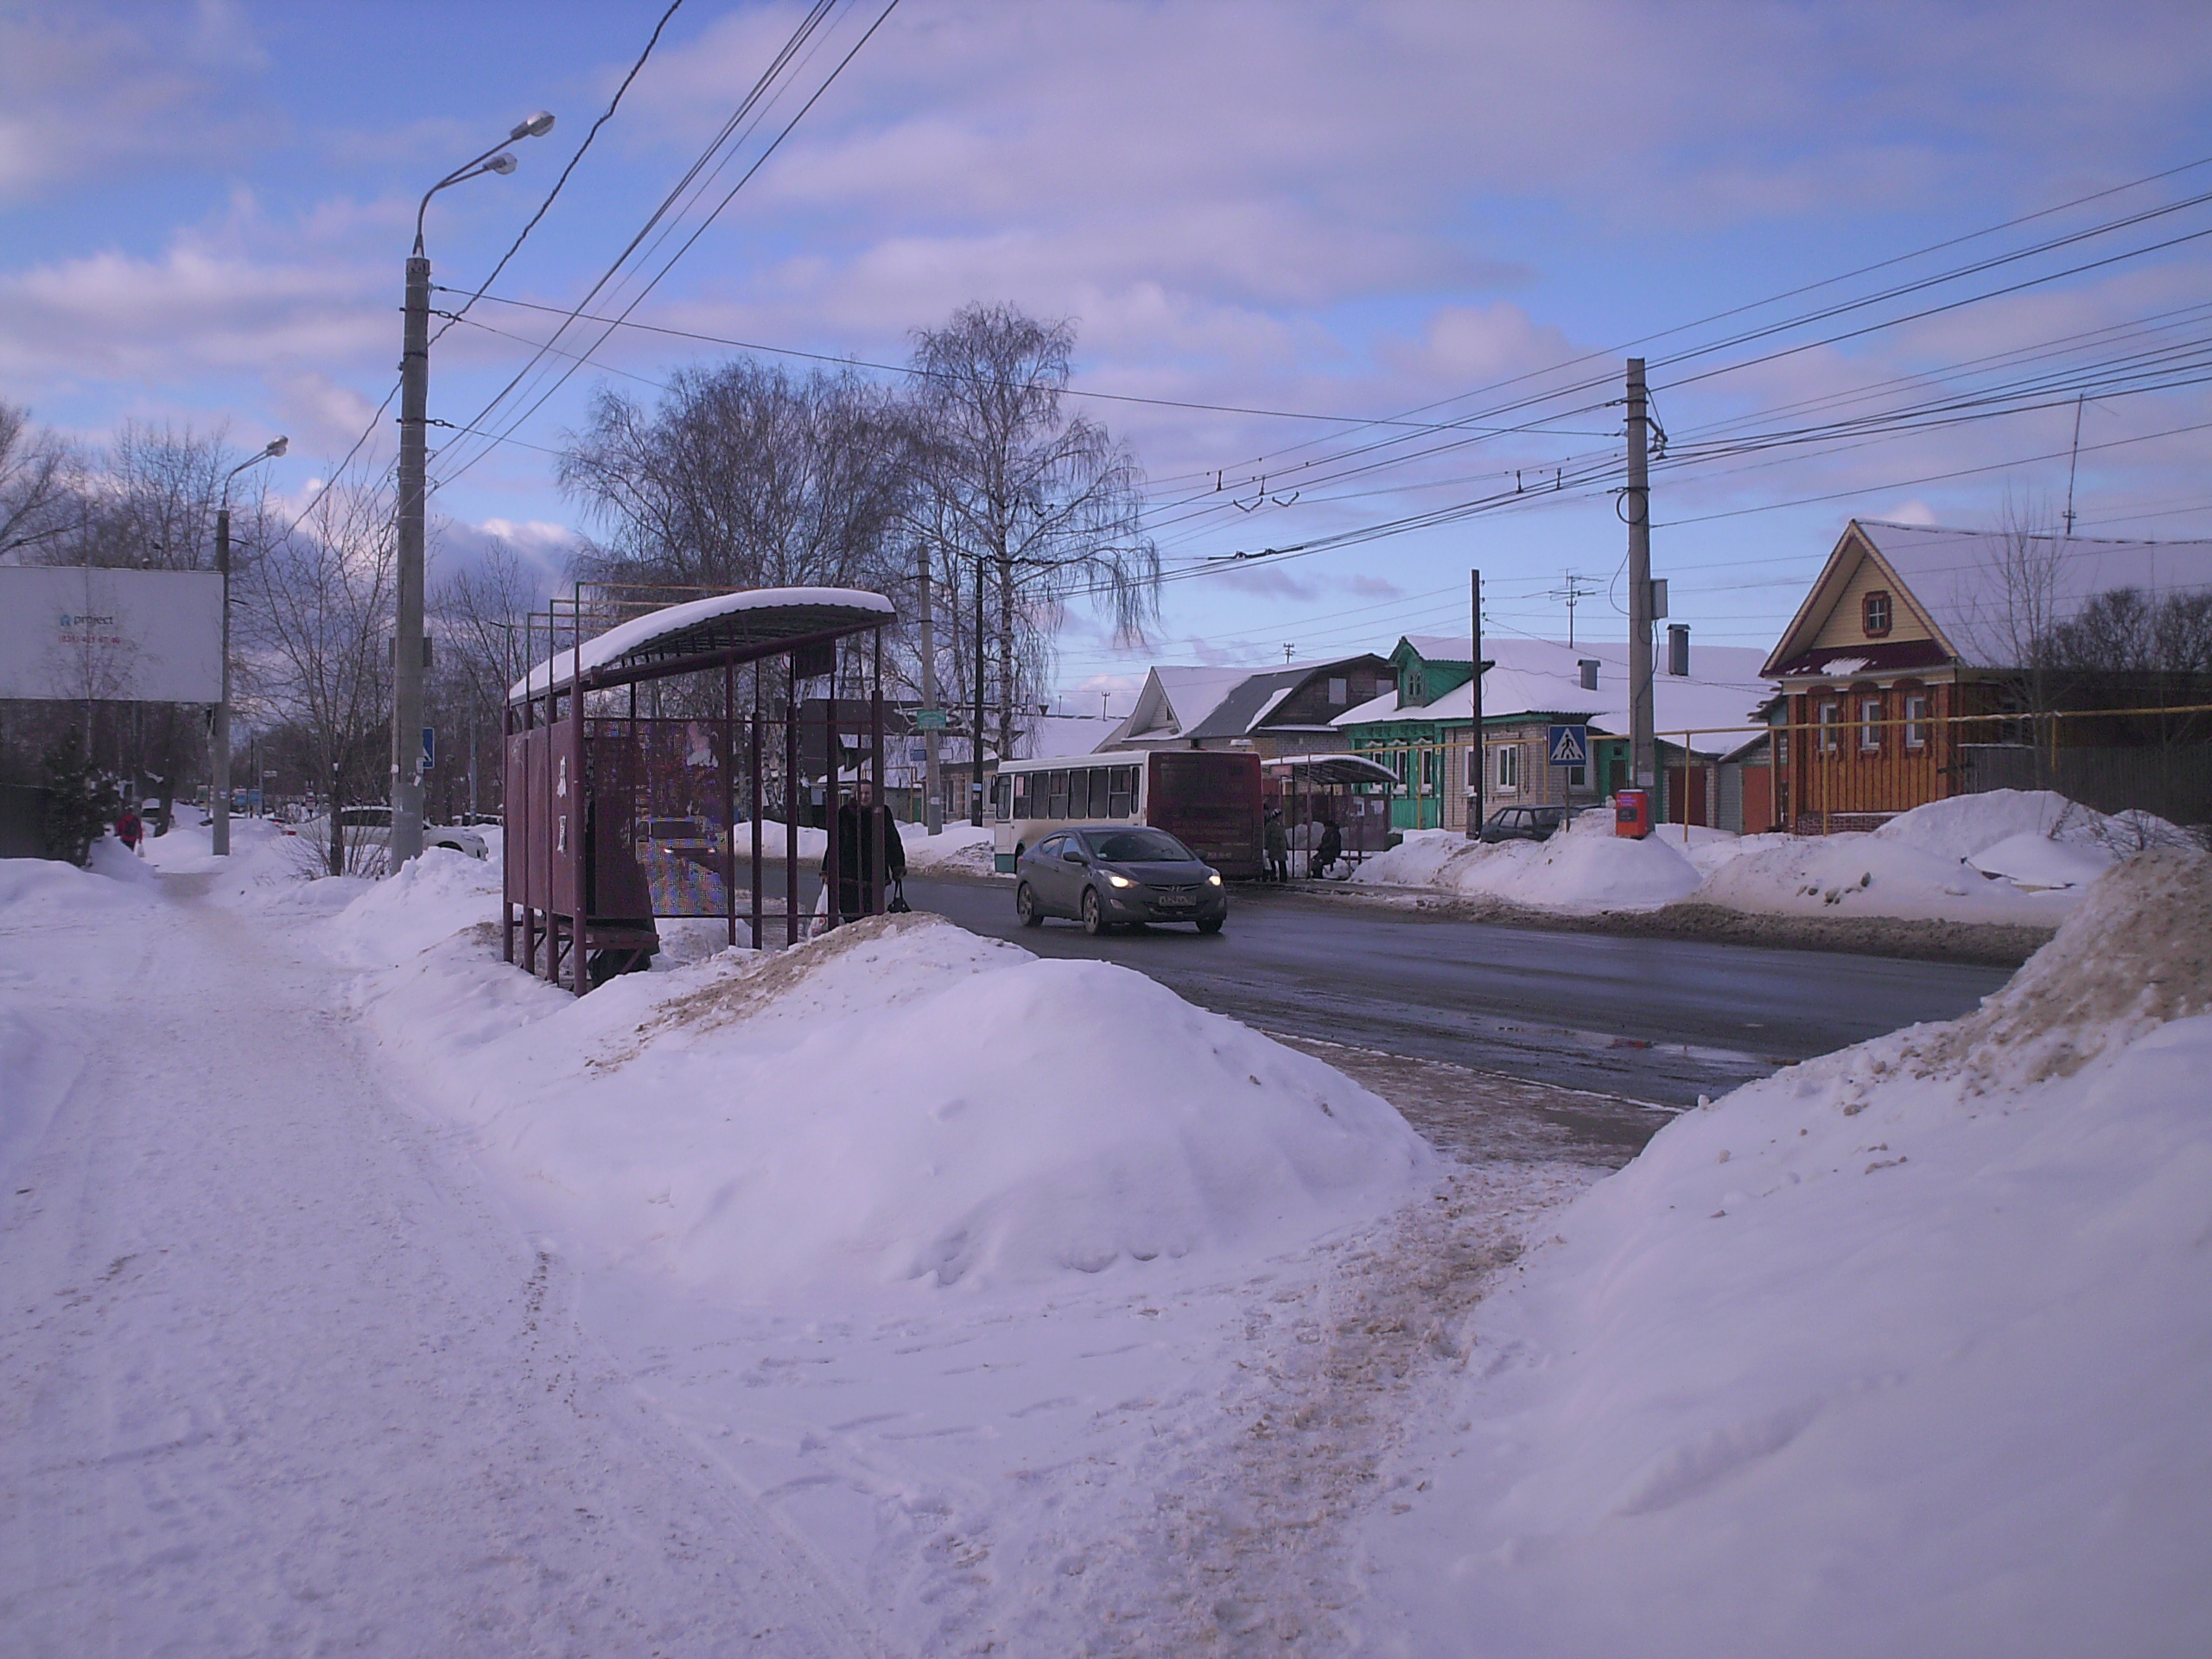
[0,564,224,703]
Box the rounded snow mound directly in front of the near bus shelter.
[340,902,1431,1299]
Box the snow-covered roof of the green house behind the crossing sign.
[1334,635,1774,752]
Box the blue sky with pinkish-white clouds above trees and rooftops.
[0,0,2212,708]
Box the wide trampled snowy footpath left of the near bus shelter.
[0,880,880,1659]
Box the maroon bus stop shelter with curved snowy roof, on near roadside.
[502,588,898,995]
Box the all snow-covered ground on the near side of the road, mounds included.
[0,834,2212,1659]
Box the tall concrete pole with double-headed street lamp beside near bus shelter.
[390,111,553,869]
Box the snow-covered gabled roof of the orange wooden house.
[1767,518,2212,675]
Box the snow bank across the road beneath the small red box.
[1354,812,1699,913]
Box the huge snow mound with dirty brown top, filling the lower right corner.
[1367,852,2212,1659]
